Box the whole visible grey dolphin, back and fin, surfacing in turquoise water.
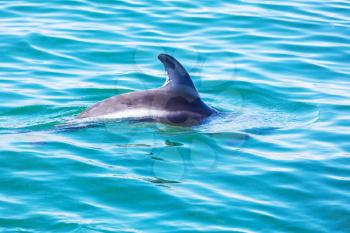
[78,54,216,126]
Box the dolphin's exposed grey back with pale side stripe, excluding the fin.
[78,87,212,123]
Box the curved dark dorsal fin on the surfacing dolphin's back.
[158,54,198,95]
